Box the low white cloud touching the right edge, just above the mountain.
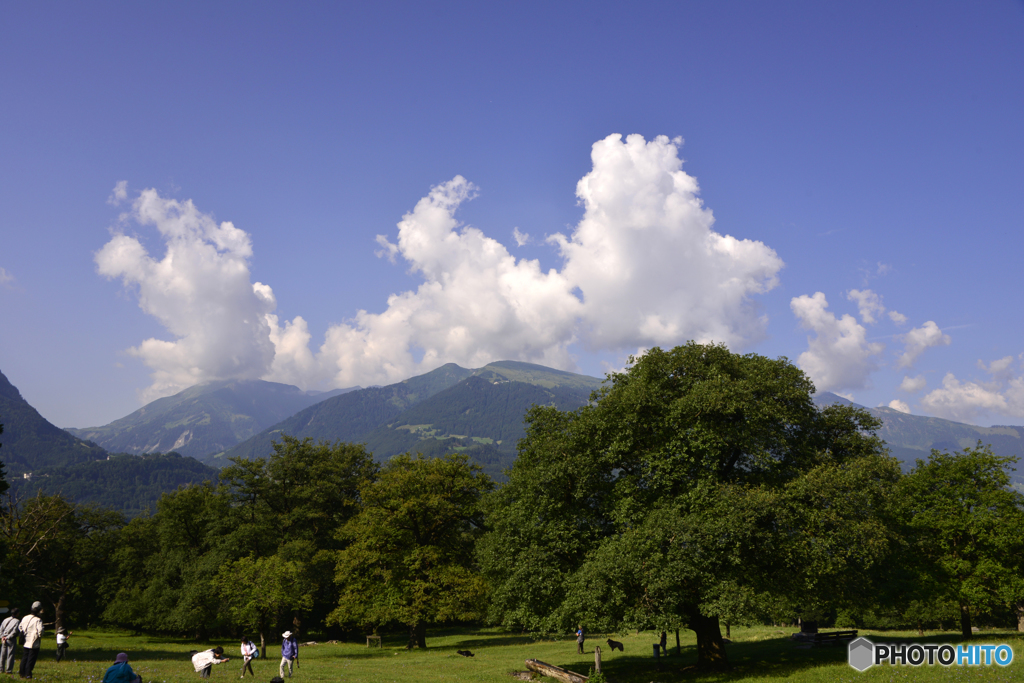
[921,356,1024,424]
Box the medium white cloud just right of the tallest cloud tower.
[790,292,885,391]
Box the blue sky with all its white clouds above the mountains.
[0,0,1024,427]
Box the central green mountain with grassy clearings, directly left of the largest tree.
[362,374,600,479]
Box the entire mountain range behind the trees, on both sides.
[0,360,1024,514]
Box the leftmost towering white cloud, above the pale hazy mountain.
[95,185,275,400]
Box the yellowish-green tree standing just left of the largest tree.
[331,455,493,647]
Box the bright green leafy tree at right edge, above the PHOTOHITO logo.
[901,442,1024,638]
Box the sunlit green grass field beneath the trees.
[15,627,1024,683]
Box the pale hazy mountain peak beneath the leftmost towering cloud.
[68,380,351,457]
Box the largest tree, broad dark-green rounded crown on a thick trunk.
[479,343,899,667]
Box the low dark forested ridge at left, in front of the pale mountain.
[4,454,219,517]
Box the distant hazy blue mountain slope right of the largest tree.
[814,391,1024,485]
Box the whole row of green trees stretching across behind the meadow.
[0,343,1024,667]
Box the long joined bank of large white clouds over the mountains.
[96,135,783,396]
